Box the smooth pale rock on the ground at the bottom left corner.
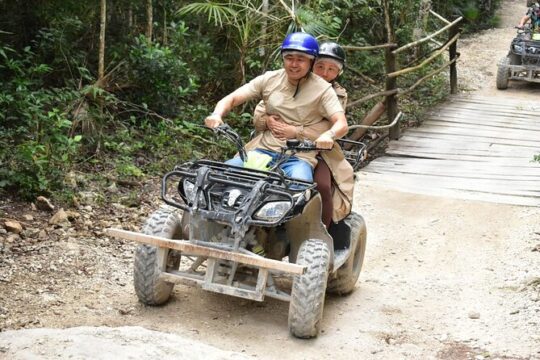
[0,326,248,360]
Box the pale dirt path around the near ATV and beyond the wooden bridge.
[0,0,540,360]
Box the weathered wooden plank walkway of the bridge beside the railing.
[358,92,540,206]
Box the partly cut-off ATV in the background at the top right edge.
[496,24,540,90]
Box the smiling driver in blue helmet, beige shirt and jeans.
[205,33,348,182]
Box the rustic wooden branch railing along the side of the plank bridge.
[344,8,462,140]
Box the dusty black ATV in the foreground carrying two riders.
[107,125,366,338]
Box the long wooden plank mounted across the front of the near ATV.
[105,229,306,275]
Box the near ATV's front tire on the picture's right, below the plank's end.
[289,239,330,339]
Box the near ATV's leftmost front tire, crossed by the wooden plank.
[133,208,182,305]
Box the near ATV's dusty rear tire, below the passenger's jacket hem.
[326,212,367,295]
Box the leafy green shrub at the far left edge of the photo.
[0,47,81,198]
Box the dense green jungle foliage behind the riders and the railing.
[0,0,497,198]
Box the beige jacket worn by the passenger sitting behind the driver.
[252,83,354,222]
